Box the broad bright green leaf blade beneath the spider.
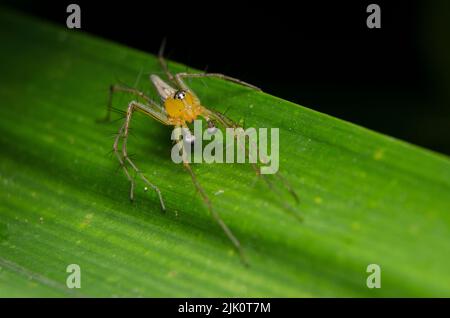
[0,9,450,297]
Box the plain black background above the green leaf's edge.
[2,0,450,154]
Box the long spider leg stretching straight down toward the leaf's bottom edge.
[178,133,249,266]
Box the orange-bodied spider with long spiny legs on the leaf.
[101,45,298,265]
